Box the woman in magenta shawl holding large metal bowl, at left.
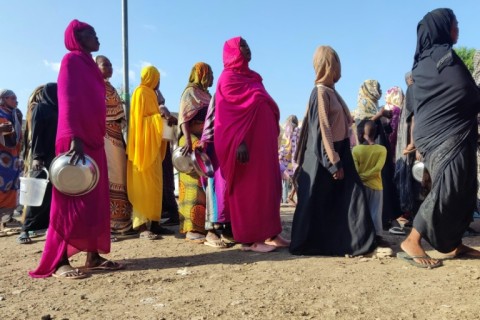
[30,20,123,279]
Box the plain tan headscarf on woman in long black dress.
[313,46,342,88]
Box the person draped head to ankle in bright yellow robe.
[127,66,167,240]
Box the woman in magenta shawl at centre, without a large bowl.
[214,37,289,252]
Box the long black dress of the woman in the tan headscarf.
[290,88,376,256]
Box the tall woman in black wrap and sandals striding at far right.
[398,9,480,268]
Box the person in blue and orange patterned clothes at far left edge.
[0,89,23,234]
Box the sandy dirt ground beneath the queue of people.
[0,207,480,320]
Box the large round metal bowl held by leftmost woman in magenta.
[50,153,99,196]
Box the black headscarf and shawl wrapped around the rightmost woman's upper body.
[412,9,480,155]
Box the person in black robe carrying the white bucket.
[17,83,58,244]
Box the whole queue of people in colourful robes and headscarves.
[0,9,480,279]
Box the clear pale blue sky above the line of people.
[0,0,480,121]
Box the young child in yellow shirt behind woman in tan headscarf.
[352,121,387,237]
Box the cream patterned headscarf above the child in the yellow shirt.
[355,80,382,120]
